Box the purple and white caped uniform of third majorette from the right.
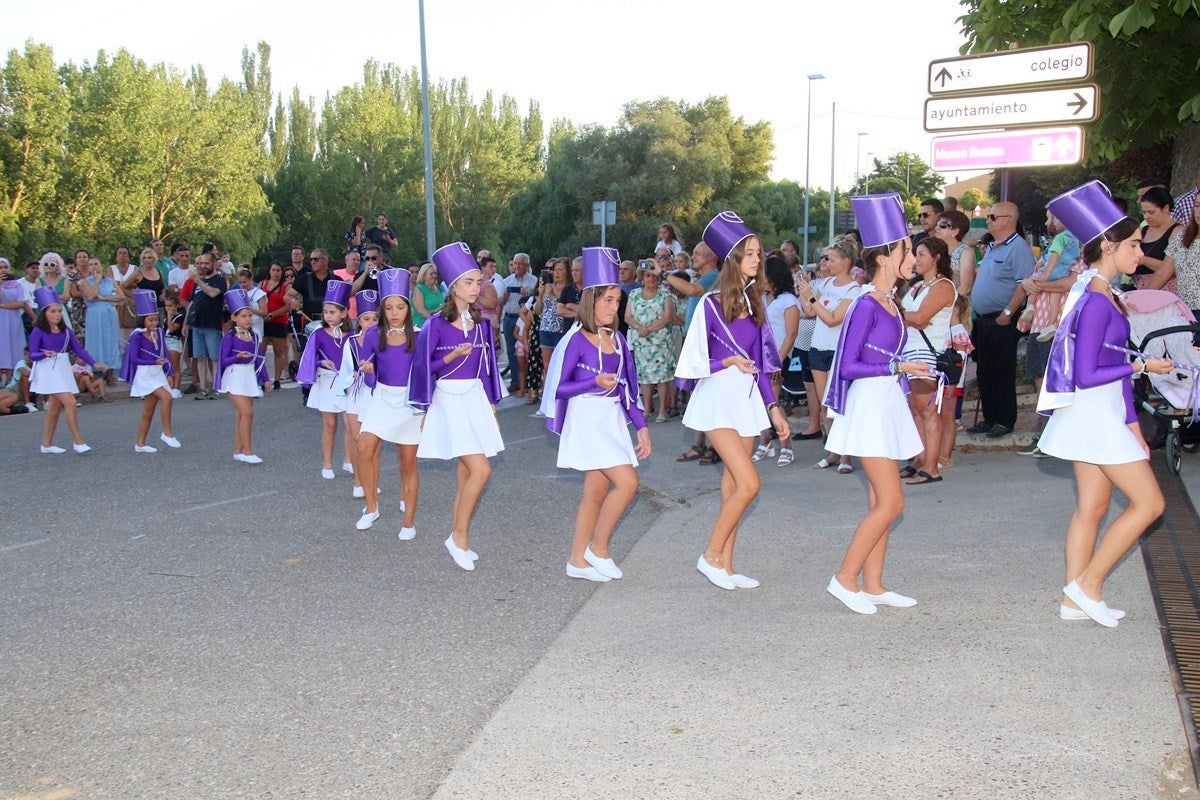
[676,293,780,437]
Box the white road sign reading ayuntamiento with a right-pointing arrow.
[925,84,1100,133]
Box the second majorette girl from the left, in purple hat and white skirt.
[121,289,179,453]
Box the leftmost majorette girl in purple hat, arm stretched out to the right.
[29,287,108,455]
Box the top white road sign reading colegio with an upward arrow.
[929,42,1093,95]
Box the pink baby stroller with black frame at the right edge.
[1124,289,1200,475]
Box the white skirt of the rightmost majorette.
[1038,380,1146,464]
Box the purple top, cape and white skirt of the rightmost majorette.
[1038,284,1146,464]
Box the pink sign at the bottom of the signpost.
[930,126,1084,173]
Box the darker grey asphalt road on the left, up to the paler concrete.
[0,390,658,799]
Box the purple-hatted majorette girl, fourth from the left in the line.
[296,281,353,481]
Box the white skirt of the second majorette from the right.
[826,375,925,461]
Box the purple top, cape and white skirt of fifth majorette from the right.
[408,314,504,459]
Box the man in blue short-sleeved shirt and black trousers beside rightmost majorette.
[967,203,1036,439]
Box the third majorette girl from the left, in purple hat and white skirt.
[216,289,271,464]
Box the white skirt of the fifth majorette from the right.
[416,378,504,461]
